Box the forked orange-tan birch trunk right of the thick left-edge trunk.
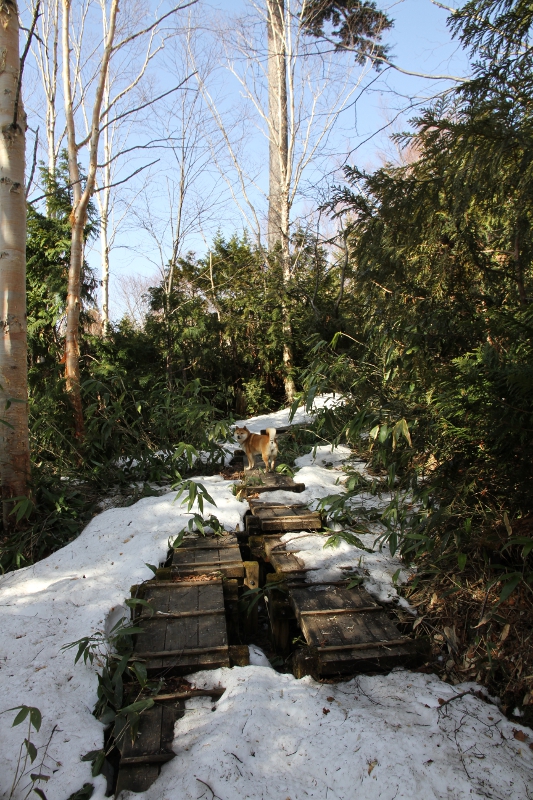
[61,0,118,439]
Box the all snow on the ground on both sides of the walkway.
[0,404,533,800]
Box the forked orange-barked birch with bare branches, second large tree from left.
[52,0,195,439]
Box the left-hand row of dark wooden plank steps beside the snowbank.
[116,534,252,794]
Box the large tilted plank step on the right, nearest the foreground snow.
[288,583,420,677]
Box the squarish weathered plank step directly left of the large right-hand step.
[133,580,229,674]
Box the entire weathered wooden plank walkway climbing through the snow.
[116,462,421,794]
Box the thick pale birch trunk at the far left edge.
[0,0,30,529]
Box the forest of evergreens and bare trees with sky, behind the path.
[0,0,533,705]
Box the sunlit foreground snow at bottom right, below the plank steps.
[129,666,533,800]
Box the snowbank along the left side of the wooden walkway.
[0,476,247,800]
